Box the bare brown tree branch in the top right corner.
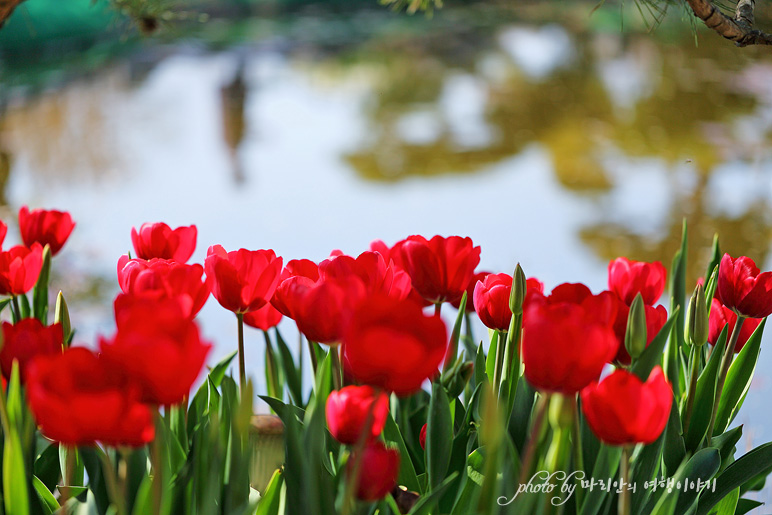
[686,0,772,46]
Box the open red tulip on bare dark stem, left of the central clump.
[204,245,282,313]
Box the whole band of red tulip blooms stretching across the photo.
[0,207,772,513]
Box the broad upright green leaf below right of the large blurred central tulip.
[426,381,453,491]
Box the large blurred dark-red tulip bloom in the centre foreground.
[343,295,448,395]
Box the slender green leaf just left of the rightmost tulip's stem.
[684,326,727,451]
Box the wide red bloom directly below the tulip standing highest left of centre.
[118,255,210,318]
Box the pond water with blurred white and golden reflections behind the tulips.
[0,4,772,452]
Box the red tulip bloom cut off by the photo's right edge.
[716,254,772,318]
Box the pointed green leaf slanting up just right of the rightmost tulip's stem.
[715,318,767,433]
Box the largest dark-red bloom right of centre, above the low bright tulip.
[521,297,617,395]
